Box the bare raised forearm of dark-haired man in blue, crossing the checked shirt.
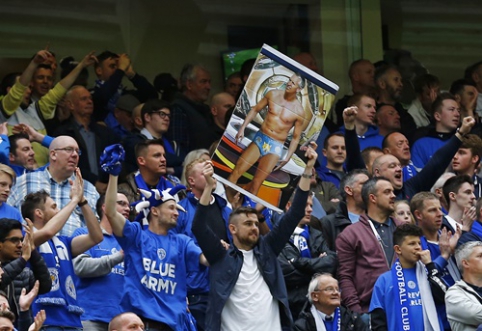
[30,168,84,247]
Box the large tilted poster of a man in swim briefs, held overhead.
[212,45,338,211]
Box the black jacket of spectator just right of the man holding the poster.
[278,227,338,319]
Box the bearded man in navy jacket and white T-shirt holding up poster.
[192,143,317,330]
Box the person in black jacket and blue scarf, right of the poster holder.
[278,195,337,319]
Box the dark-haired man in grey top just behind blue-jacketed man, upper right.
[408,74,440,128]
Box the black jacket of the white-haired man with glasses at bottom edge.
[293,304,370,331]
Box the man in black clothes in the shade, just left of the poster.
[169,64,213,153]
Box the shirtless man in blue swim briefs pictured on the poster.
[228,74,305,195]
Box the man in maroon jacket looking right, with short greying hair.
[336,178,398,321]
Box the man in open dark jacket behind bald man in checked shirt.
[54,85,120,193]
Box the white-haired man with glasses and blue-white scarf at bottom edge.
[294,274,369,331]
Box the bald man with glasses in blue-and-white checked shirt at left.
[7,136,99,236]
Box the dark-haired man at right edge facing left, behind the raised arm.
[452,134,482,199]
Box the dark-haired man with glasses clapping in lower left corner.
[0,218,52,330]
